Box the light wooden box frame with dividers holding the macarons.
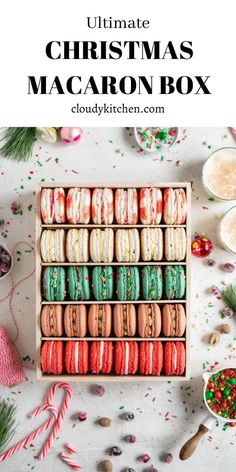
[36,182,191,382]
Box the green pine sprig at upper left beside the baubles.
[0,128,36,161]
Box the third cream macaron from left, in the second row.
[89,228,114,263]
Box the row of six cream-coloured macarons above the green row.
[40,227,187,263]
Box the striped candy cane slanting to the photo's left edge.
[0,404,58,462]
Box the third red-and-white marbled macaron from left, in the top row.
[92,188,114,225]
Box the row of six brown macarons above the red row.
[41,303,186,338]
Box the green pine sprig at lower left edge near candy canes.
[0,400,16,451]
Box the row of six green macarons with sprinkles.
[42,265,186,302]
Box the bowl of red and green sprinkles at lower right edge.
[204,368,236,422]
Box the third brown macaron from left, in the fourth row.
[88,304,111,338]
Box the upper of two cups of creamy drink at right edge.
[202,147,236,202]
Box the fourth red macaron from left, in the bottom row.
[114,341,138,375]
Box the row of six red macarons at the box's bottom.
[41,341,186,376]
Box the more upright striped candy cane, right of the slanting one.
[38,382,72,460]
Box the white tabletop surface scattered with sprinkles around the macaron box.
[0,128,236,472]
